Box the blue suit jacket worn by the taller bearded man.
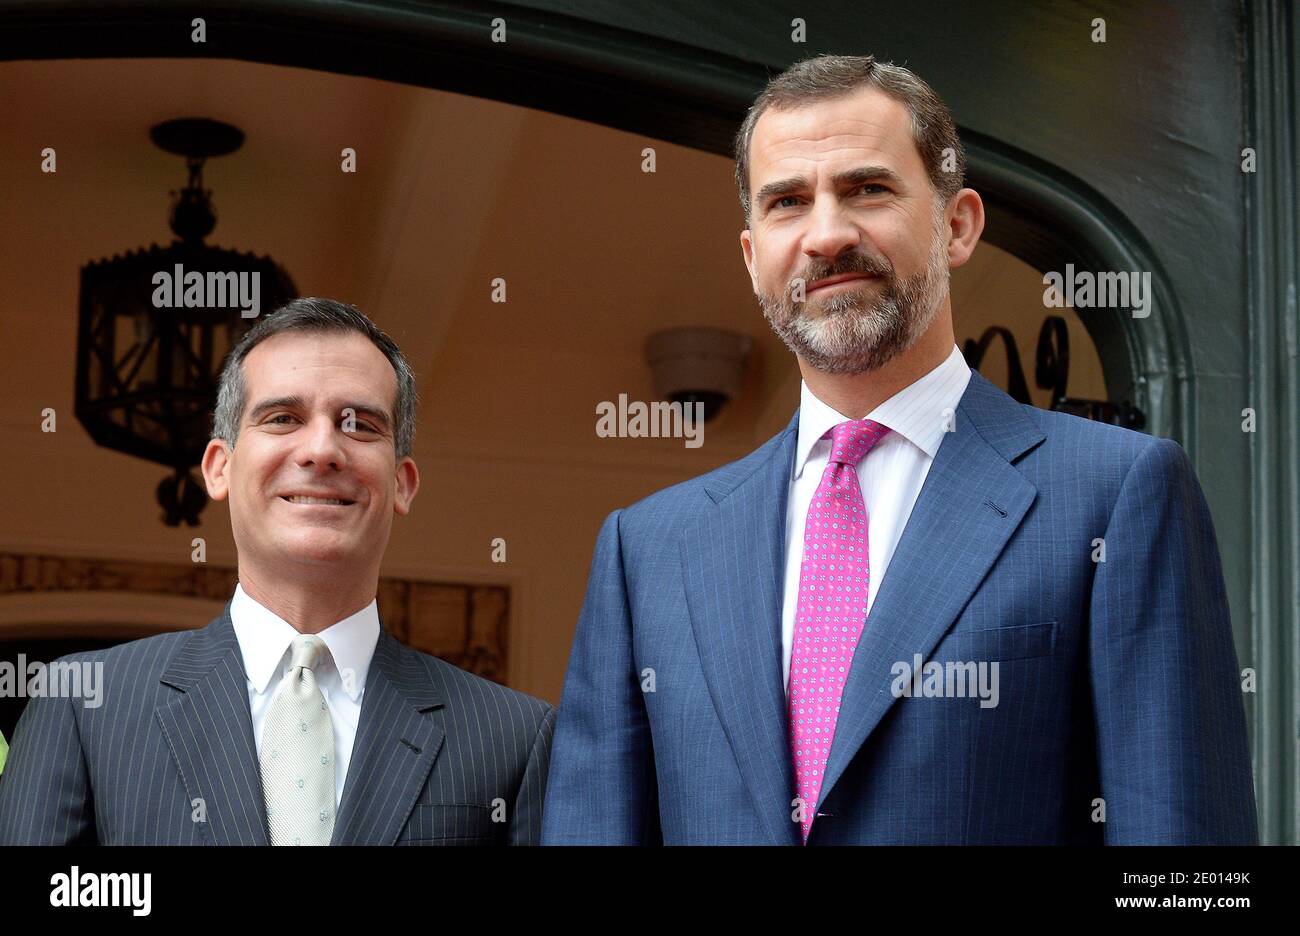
[542,373,1256,845]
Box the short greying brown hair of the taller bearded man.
[735,55,966,228]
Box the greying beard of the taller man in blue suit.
[758,234,949,374]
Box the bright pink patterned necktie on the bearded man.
[789,419,889,844]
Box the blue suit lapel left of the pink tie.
[681,413,798,845]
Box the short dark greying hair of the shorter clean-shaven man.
[212,298,419,459]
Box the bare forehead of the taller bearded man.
[750,87,926,192]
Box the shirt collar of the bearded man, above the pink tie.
[794,345,971,477]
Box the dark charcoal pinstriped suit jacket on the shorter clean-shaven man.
[0,605,555,845]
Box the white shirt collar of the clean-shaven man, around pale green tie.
[230,585,380,702]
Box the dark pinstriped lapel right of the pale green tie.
[330,629,445,845]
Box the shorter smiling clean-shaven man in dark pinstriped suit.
[0,299,555,845]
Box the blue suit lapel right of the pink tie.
[818,372,1044,809]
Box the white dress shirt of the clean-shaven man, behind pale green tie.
[230,585,380,809]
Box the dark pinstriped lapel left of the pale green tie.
[155,605,269,845]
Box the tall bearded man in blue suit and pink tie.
[542,56,1256,845]
